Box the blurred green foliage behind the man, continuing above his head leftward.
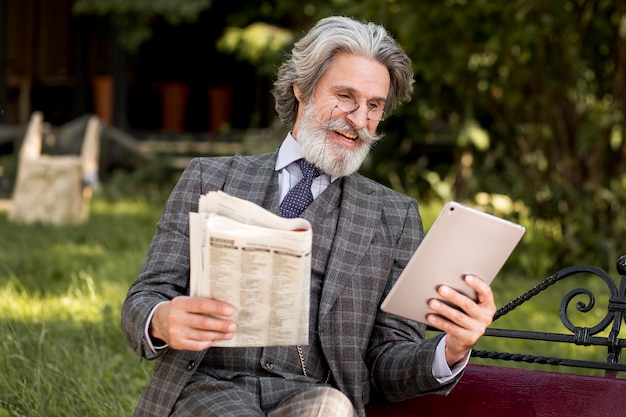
[75,0,626,268]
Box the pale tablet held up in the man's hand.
[381,201,526,323]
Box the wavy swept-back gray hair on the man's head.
[272,16,414,125]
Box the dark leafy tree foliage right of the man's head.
[352,0,626,265]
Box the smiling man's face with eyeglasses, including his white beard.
[293,54,389,176]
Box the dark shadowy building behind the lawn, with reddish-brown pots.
[0,0,274,132]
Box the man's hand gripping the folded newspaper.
[149,296,237,351]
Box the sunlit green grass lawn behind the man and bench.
[0,193,620,417]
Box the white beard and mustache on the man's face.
[296,104,383,177]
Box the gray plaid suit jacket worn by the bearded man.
[122,151,460,417]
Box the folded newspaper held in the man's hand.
[189,191,312,347]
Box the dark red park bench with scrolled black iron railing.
[367,256,626,417]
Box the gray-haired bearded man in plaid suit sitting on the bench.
[122,17,495,417]
